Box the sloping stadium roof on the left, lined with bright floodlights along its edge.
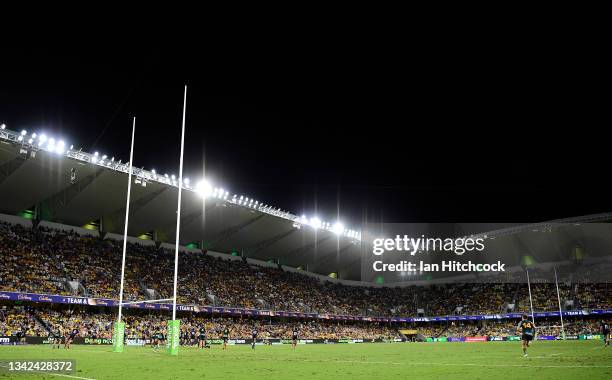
[0,128,360,278]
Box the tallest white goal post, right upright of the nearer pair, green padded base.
[168,85,187,355]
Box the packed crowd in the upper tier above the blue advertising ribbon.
[0,223,612,316]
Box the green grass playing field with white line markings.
[0,341,612,380]
